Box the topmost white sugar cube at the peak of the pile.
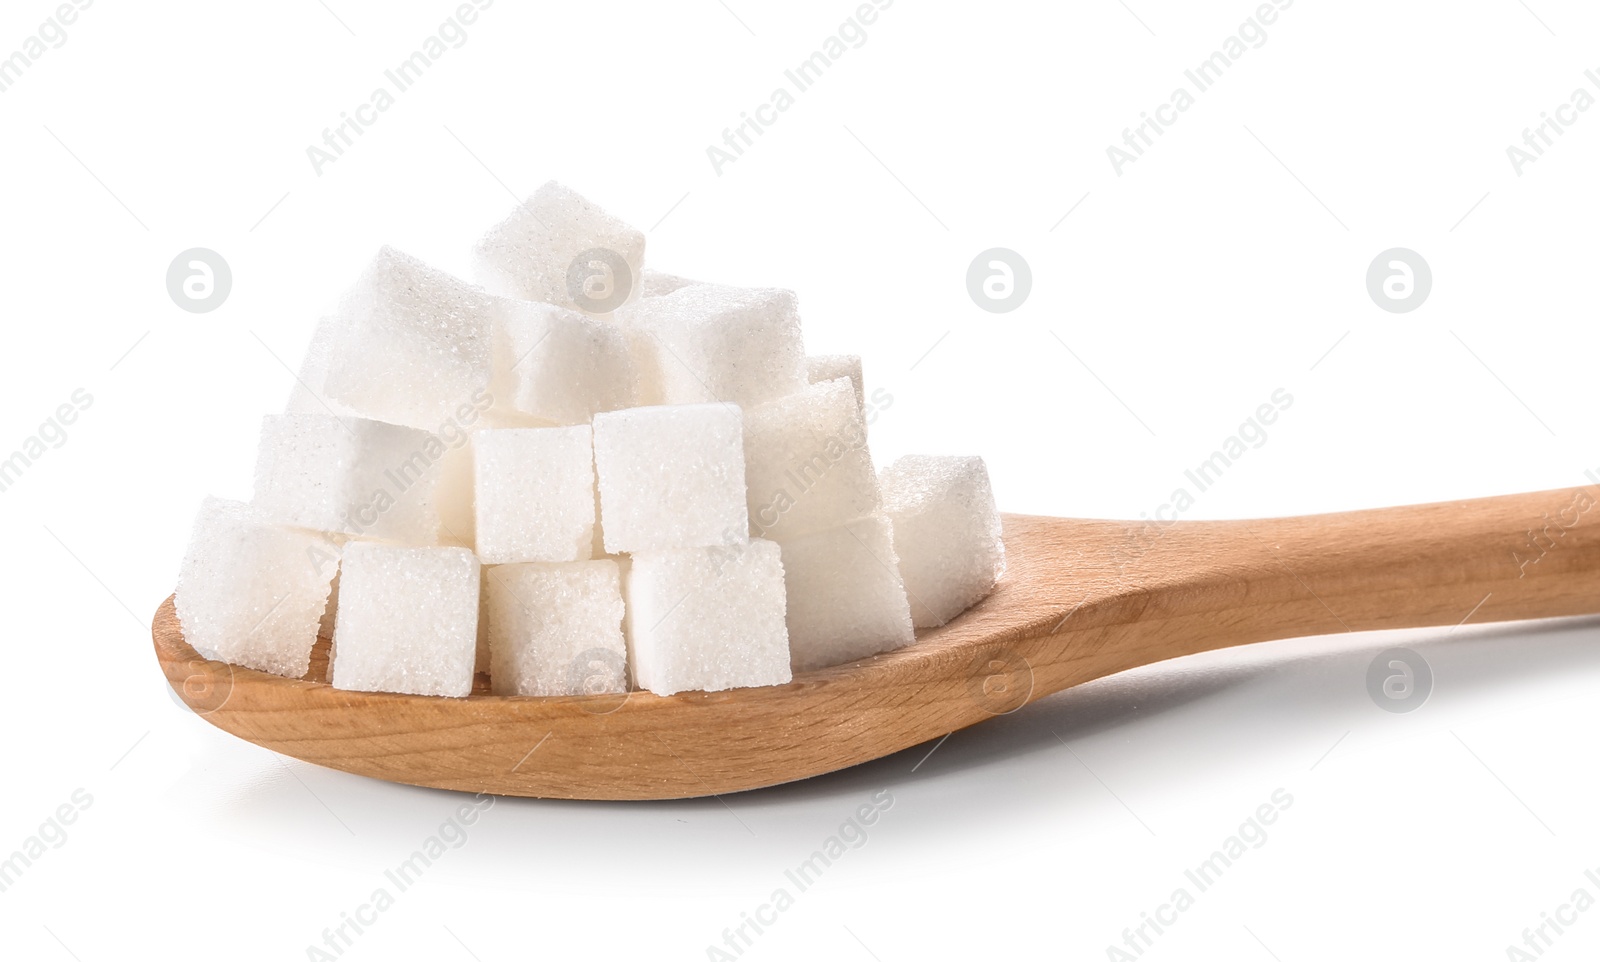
[474,181,645,314]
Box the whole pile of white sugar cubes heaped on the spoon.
[176,182,1005,696]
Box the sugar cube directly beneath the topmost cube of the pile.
[491,299,635,424]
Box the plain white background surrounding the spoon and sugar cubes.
[0,0,1600,962]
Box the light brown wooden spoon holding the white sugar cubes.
[154,488,1600,799]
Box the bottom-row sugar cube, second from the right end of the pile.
[782,515,917,671]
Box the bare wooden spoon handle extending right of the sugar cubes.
[1006,487,1600,696]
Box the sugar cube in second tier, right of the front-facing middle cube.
[744,378,882,541]
